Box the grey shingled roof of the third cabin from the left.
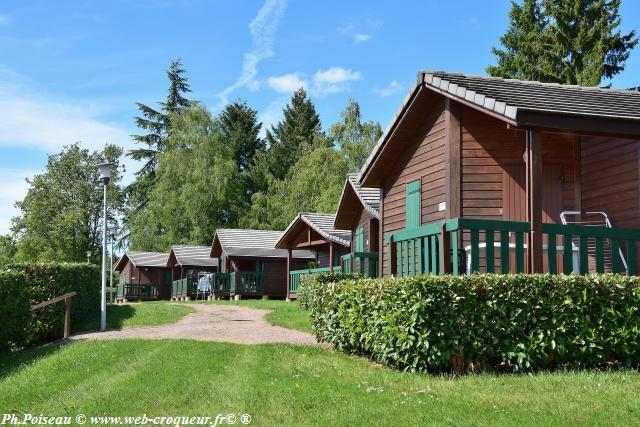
[210,228,315,259]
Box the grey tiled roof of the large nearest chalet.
[358,71,640,185]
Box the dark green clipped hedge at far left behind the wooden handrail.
[3,263,100,345]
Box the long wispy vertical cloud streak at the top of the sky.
[218,0,286,104]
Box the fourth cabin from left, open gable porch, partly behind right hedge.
[275,213,351,298]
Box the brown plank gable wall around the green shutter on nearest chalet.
[380,98,447,274]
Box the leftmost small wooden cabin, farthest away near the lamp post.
[115,252,171,302]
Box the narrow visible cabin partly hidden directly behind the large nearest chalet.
[333,174,380,277]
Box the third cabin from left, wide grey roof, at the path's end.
[210,229,315,299]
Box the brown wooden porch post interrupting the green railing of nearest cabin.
[526,130,544,273]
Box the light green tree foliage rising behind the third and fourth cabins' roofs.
[240,144,348,230]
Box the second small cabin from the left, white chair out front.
[167,245,218,300]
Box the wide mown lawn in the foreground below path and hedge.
[0,340,640,426]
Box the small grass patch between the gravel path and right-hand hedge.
[189,300,313,333]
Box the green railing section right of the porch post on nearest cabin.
[542,224,640,275]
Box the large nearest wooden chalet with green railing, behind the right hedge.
[358,71,640,275]
